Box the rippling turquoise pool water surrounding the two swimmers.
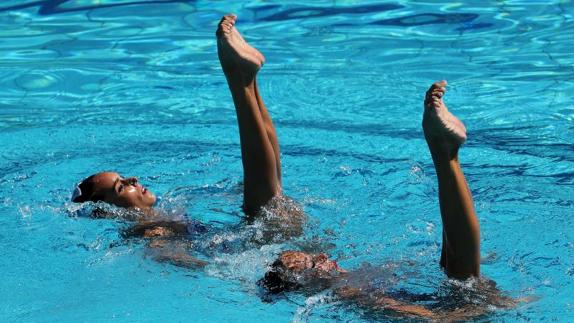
[0,0,574,322]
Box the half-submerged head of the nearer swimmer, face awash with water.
[259,251,346,293]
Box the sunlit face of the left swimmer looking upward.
[88,172,156,209]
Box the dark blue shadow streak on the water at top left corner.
[0,0,195,16]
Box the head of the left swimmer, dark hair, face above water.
[72,172,156,210]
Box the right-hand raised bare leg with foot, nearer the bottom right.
[423,81,480,279]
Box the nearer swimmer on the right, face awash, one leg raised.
[260,81,528,320]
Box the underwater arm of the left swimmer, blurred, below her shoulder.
[146,239,208,269]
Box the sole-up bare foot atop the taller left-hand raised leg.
[215,15,265,79]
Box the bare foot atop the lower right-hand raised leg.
[423,81,466,157]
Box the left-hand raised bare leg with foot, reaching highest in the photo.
[216,15,281,215]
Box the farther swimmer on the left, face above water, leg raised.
[72,15,304,264]
